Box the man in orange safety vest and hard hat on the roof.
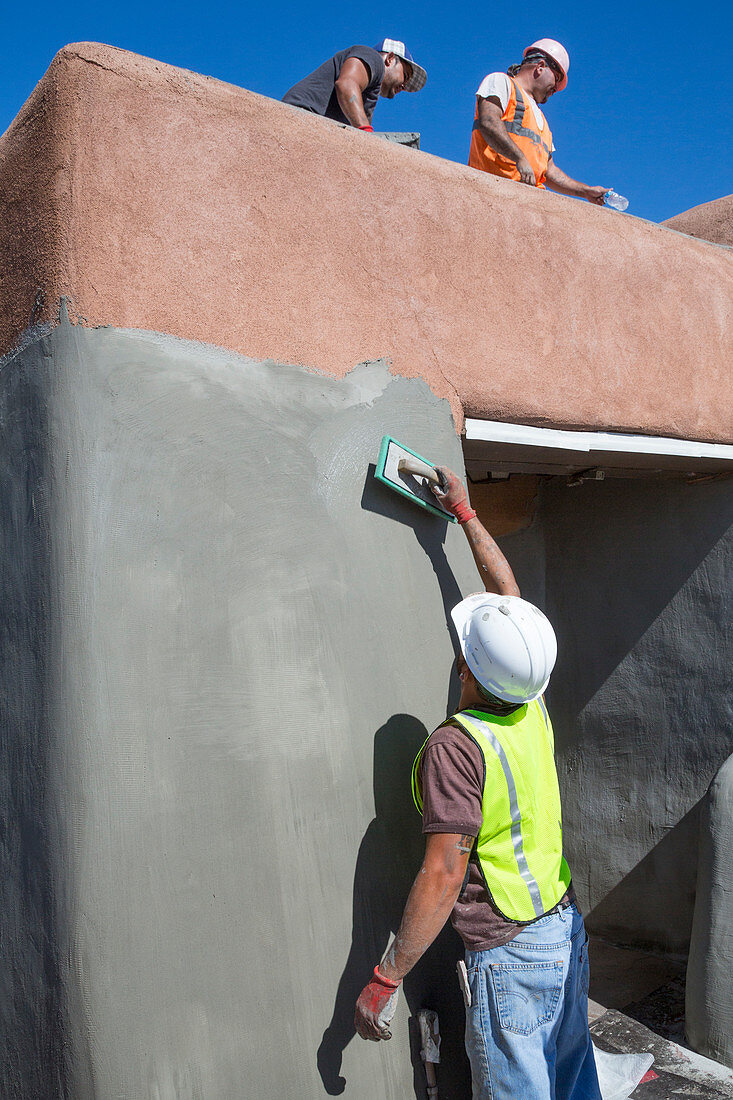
[469,39,610,206]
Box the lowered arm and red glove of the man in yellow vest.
[354,833,474,1040]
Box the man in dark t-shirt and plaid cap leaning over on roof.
[283,39,427,133]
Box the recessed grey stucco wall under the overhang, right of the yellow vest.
[512,479,733,952]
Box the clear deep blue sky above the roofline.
[0,0,733,221]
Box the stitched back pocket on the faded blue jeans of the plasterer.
[491,959,562,1035]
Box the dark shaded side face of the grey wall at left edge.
[0,345,67,1100]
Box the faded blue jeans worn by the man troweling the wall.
[466,905,601,1100]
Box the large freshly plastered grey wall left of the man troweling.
[0,316,484,1100]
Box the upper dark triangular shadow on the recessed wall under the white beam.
[541,479,733,726]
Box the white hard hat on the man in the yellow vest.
[450,592,557,703]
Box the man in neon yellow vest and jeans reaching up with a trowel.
[354,466,601,1100]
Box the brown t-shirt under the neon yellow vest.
[418,726,572,952]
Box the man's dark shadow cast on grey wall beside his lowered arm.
[317,714,471,1100]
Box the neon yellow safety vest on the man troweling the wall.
[413,700,570,923]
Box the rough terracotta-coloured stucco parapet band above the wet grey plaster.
[0,43,733,442]
